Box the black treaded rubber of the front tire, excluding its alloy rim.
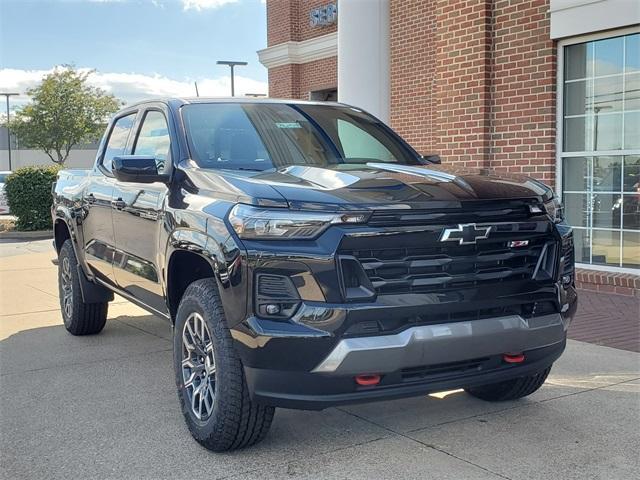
[175,278,275,452]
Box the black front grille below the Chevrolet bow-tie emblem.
[340,222,556,295]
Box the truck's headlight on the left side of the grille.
[229,204,367,240]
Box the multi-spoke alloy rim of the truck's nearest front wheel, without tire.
[182,312,216,420]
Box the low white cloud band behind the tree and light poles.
[0,68,268,113]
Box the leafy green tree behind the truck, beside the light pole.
[9,66,122,165]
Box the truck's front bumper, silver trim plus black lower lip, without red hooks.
[238,314,570,410]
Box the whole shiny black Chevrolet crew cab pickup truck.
[52,98,576,451]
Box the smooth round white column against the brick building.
[338,0,391,122]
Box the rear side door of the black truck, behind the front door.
[82,111,136,284]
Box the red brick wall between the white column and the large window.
[390,0,556,183]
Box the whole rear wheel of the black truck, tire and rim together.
[58,240,109,335]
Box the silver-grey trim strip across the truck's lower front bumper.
[313,313,567,375]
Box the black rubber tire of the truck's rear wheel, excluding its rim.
[58,240,109,336]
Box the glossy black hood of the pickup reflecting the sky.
[184,163,553,210]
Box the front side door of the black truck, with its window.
[112,106,171,313]
